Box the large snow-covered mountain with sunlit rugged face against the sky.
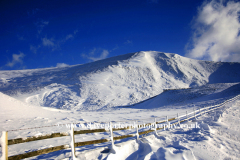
[0,51,240,110]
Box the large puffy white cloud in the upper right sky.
[186,0,240,61]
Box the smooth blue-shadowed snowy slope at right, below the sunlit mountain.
[131,83,240,109]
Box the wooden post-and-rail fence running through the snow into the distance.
[2,95,240,160]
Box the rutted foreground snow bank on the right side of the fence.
[73,101,240,160]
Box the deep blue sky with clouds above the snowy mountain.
[0,0,240,70]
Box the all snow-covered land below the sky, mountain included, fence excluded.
[0,51,240,160]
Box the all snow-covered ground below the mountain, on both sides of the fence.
[0,83,240,160]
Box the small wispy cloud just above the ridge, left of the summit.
[82,48,109,61]
